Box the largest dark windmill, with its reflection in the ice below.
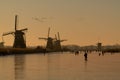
[3,15,28,48]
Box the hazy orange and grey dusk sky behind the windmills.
[0,0,120,46]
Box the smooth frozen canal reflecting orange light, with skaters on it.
[0,52,120,80]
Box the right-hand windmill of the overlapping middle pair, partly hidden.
[54,32,67,51]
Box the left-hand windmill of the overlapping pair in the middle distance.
[39,28,53,50]
